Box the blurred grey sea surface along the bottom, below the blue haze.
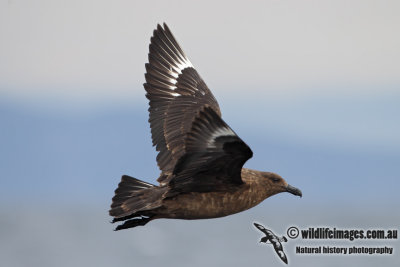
[0,204,400,267]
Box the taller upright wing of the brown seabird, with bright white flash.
[144,23,221,183]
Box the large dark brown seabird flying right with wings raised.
[109,23,302,230]
